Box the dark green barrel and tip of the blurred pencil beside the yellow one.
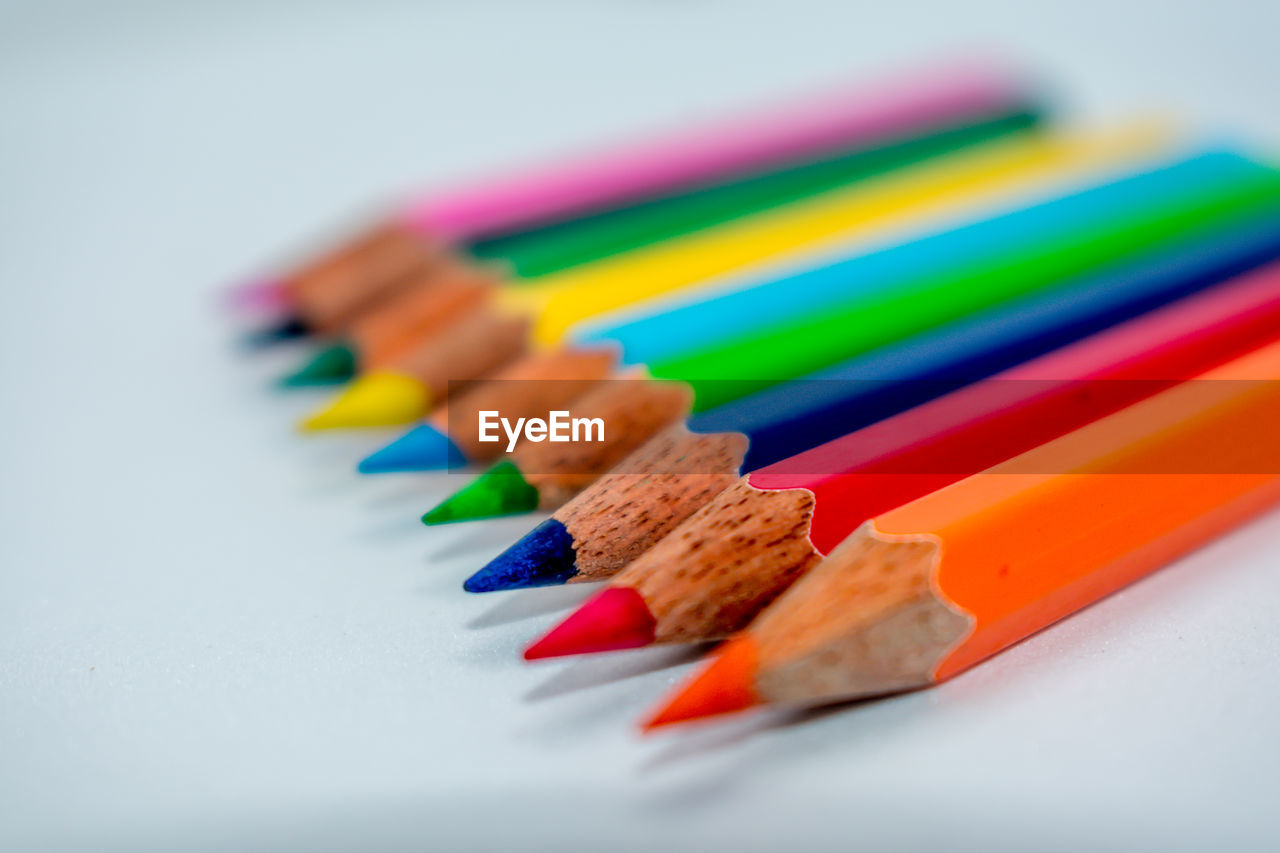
[285,106,1038,386]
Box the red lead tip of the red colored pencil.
[525,587,657,661]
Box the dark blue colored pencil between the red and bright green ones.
[465,211,1280,592]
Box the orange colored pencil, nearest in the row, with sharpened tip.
[646,333,1280,727]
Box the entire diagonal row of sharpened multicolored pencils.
[237,63,1280,726]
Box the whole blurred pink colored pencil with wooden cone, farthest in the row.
[241,64,1025,330]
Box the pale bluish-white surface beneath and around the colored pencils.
[0,0,1280,850]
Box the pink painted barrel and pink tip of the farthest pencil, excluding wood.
[233,61,1027,310]
